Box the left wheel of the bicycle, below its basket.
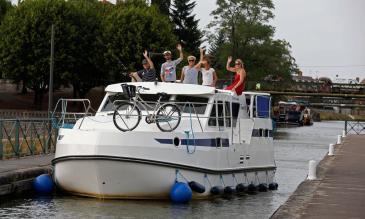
[113,102,141,132]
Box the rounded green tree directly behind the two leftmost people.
[103,4,176,81]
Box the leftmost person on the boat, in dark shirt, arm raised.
[129,50,156,81]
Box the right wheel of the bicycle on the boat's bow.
[156,103,181,132]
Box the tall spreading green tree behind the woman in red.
[210,0,296,80]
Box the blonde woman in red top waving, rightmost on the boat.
[226,56,246,95]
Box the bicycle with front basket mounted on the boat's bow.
[113,84,181,132]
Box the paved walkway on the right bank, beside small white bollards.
[272,135,365,219]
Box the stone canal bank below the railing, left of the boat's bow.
[0,154,54,196]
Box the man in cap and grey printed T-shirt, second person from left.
[161,44,184,82]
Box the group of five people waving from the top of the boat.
[129,44,246,95]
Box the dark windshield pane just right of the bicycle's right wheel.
[175,95,209,115]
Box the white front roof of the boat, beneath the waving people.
[105,82,215,95]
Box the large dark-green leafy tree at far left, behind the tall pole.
[0,0,103,107]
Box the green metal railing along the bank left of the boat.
[0,119,58,159]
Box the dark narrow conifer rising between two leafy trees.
[171,0,202,55]
